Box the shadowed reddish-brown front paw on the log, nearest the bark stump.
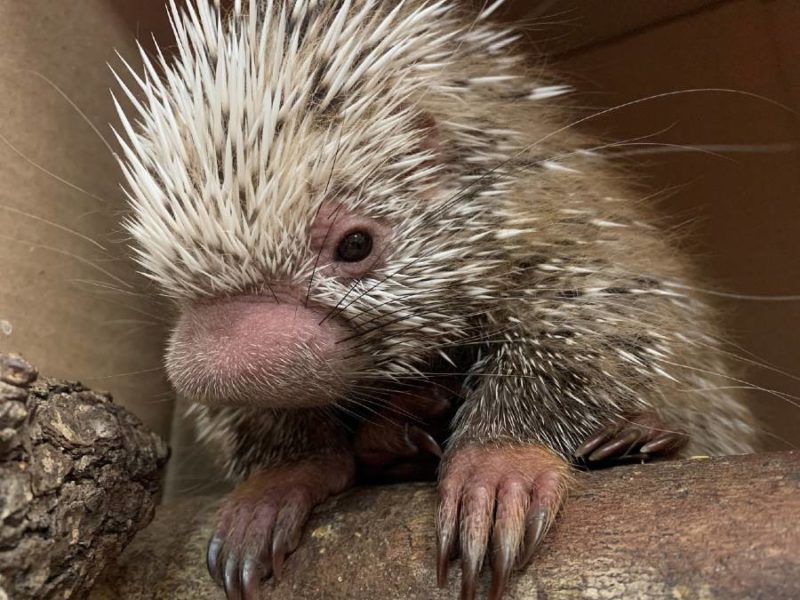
[207,459,353,600]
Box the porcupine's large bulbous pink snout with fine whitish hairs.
[166,296,349,408]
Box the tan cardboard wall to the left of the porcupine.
[0,0,172,434]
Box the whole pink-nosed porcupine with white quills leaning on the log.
[111,0,754,600]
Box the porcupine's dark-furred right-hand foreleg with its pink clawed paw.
[437,338,668,600]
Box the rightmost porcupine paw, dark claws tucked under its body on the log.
[574,413,689,464]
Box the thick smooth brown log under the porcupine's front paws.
[90,452,800,600]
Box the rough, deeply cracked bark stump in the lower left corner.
[0,355,167,600]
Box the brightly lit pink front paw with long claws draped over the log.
[437,445,569,600]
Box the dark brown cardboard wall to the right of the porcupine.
[556,0,800,448]
